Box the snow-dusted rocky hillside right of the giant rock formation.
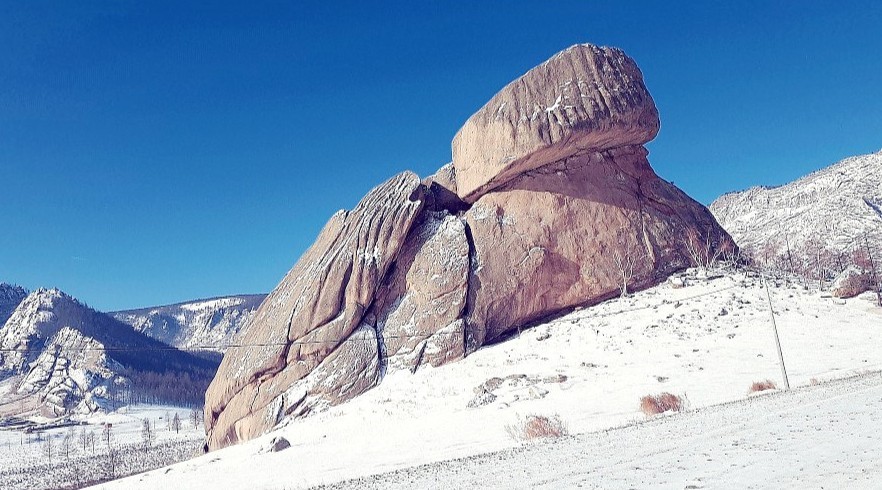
[710,151,882,255]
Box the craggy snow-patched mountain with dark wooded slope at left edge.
[0,289,217,416]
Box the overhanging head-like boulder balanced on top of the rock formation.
[452,44,659,202]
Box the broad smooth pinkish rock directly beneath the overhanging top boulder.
[465,146,727,348]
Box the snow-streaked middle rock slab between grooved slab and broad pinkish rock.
[365,211,469,370]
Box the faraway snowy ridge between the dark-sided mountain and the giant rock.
[110,294,266,352]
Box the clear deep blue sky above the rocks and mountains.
[0,0,882,310]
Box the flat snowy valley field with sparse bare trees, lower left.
[0,405,204,490]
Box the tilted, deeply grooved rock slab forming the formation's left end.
[205,172,425,449]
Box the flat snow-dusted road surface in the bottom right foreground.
[323,373,882,490]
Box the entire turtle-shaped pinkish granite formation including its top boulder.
[205,45,727,449]
